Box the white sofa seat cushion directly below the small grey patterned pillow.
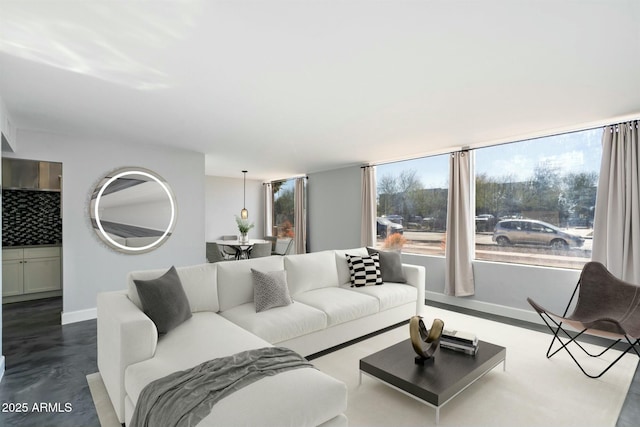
[220,302,327,344]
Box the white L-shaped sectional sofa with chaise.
[98,248,425,427]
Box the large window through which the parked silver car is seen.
[475,128,603,269]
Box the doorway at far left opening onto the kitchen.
[2,157,62,325]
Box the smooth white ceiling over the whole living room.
[0,0,640,180]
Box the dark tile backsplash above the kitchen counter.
[2,190,62,246]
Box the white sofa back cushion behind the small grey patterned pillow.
[217,256,284,311]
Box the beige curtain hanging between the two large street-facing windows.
[444,151,475,296]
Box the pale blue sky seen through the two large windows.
[376,128,603,188]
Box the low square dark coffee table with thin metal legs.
[360,339,507,424]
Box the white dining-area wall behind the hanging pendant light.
[205,176,264,242]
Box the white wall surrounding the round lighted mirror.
[3,130,205,323]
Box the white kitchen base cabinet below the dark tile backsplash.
[2,247,61,297]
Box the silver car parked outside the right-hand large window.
[492,219,584,249]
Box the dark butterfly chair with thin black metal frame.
[527,262,640,378]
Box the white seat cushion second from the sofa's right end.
[293,288,379,326]
